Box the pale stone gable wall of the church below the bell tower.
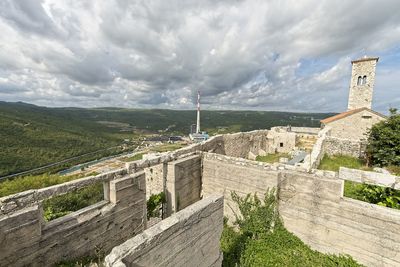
[326,110,385,140]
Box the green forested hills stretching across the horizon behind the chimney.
[0,101,332,176]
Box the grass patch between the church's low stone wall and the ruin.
[318,155,371,172]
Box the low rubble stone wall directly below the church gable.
[323,136,364,158]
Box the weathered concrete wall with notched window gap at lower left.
[0,173,146,266]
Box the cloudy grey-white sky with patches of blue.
[0,0,400,112]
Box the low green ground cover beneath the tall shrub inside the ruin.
[221,225,362,267]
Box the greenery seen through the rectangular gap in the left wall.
[43,183,104,221]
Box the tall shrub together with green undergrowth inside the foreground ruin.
[221,190,360,266]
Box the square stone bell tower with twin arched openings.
[347,56,379,110]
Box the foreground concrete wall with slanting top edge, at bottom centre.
[105,196,223,267]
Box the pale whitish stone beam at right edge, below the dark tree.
[339,167,400,190]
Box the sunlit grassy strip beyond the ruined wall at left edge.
[0,174,84,197]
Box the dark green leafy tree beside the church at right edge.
[367,108,400,166]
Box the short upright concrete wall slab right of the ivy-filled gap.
[166,155,201,215]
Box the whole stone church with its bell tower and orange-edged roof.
[321,57,386,141]
